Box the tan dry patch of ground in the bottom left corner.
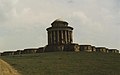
[0,59,20,75]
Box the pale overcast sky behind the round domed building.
[0,0,120,52]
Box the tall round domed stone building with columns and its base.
[45,19,79,52]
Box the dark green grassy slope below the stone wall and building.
[0,52,120,75]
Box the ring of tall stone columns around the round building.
[48,30,73,45]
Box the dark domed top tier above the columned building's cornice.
[51,19,68,27]
